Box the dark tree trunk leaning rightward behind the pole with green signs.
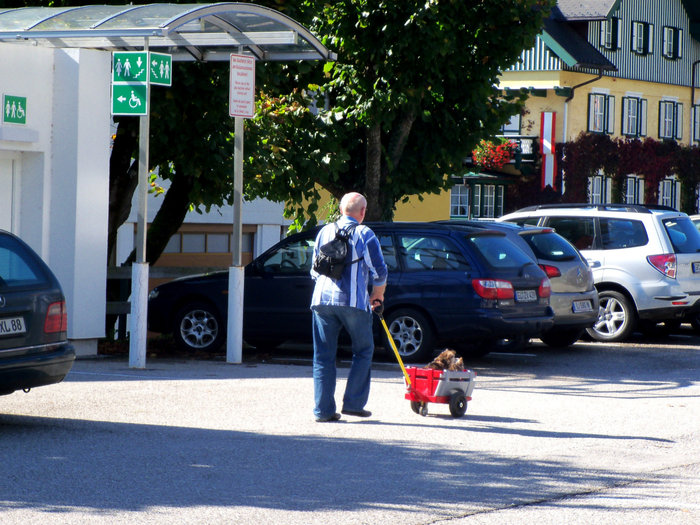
[125,166,194,264]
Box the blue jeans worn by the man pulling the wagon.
[311,305,374,417]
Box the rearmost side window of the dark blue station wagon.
[399,235,470,271]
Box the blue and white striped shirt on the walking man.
[311,215,388,311]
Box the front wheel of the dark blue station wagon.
[173,302,226,352]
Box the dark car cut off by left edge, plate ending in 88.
[0,230,75,395]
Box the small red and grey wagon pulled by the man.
[406,367,476,417]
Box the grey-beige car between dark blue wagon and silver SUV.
[439,220,599,347]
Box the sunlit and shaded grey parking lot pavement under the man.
[0,336,700,524]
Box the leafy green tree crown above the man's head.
[246,0,554,226]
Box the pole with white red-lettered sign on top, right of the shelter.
[226,54,255,364]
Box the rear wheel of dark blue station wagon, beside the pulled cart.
[384,308,435,361]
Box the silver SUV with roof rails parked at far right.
[498,204,700,341]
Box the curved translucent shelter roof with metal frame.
[0,2,336,61]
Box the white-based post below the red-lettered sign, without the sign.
[226,117,245,364]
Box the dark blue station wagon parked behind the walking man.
[148,223,553,361]
